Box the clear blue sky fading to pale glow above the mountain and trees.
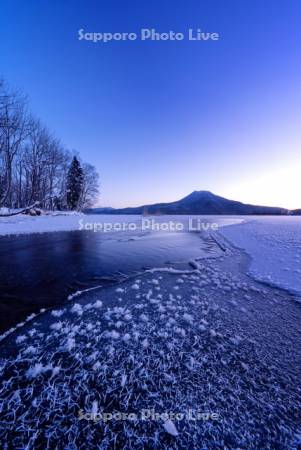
[0,0,301,209]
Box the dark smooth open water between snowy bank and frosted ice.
[0,231,203,332]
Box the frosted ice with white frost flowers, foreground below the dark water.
[0,214,301,449]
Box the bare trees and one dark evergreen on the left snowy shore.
[0,80,99,209]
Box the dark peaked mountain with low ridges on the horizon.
[86,191,288,215]
